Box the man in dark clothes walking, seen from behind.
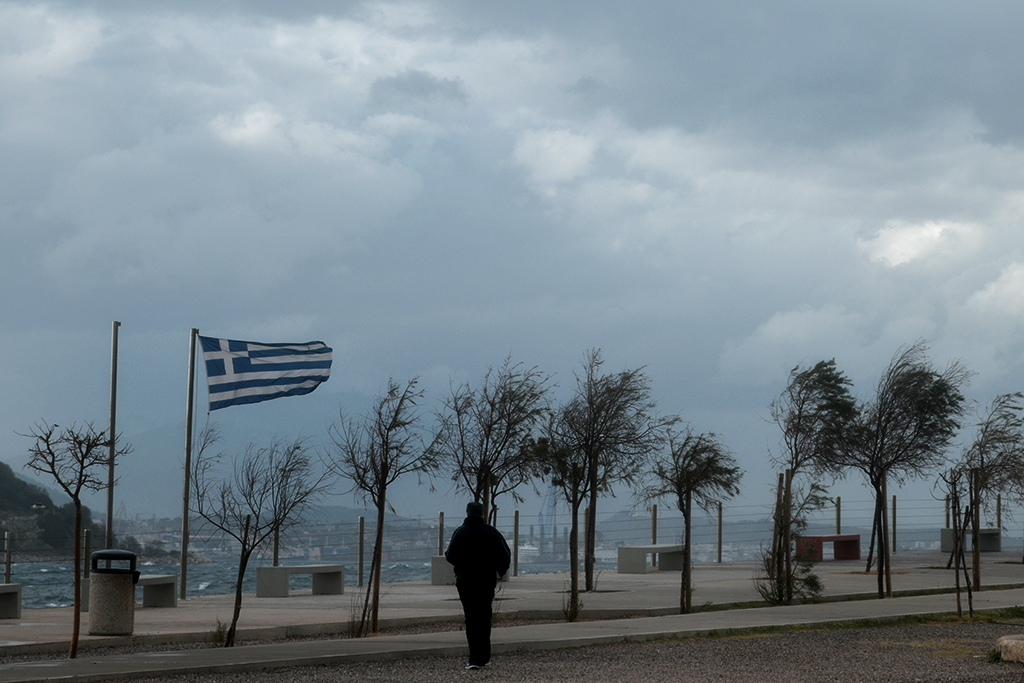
[444,503,512,669]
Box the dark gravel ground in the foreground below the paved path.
[112,622,1024,683]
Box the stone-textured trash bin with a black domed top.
[89,550,139,636]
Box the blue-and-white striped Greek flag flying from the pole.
[199,337,331,411]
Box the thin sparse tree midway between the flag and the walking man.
[330,379,437,635]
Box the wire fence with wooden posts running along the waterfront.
[4,497,1024,584]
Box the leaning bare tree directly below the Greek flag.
[189,425,327,647]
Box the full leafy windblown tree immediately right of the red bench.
[835,342,971,597]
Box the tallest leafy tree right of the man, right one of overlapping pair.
[552,349,678,592]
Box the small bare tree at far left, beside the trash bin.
[23,422,131,659]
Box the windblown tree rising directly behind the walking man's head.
[434,357,549,524]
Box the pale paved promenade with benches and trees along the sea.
[0,550,1024,683]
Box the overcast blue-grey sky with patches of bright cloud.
[0,0,1024,514]
